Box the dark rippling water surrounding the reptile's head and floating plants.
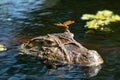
[0,0,120,80]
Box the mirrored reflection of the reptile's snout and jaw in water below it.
[47,65,101,79]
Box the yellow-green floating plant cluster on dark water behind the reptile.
[81,10,120,31]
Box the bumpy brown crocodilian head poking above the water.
[20,31,103,66]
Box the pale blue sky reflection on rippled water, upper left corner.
[0,0,59,45]
